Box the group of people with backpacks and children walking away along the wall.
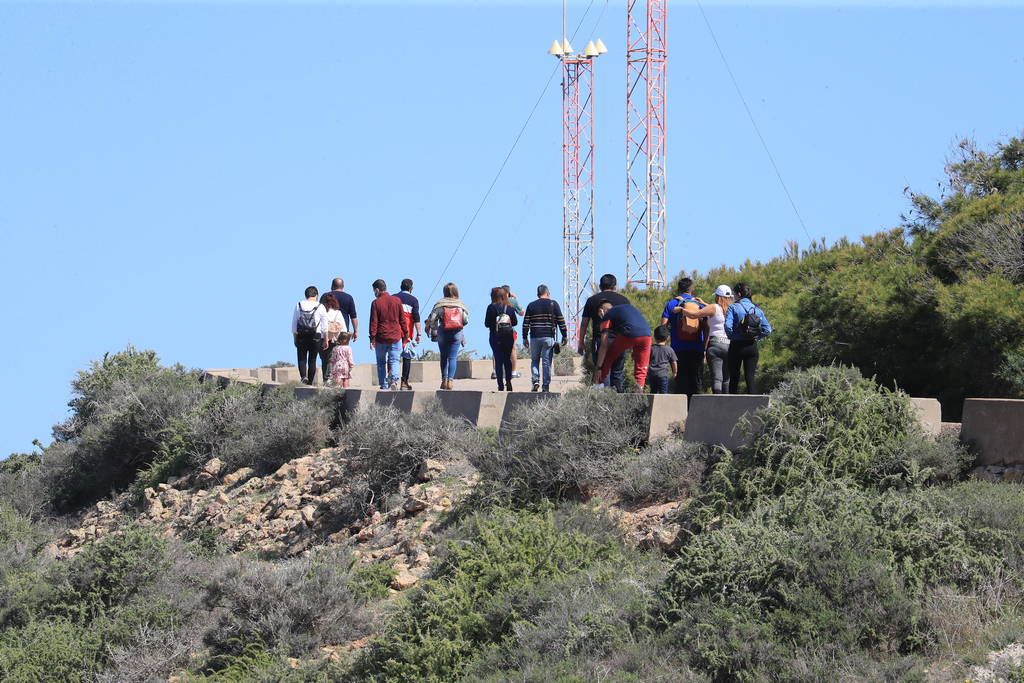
[292,273,772,396]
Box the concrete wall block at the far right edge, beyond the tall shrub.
[961,398,1024,467]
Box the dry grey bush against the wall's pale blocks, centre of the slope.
[470,388,646,501]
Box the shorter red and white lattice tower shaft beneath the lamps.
[561,56,594,348]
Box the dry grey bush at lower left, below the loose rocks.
[205,550,368,656]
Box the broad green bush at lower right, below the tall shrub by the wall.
[664,483,1009,680]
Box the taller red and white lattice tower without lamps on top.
[626,0,669,287]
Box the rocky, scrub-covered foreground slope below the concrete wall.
[0,350,1024,682]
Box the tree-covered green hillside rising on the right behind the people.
[630,137,1024,421]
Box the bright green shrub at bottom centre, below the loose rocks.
[353,507,623,681]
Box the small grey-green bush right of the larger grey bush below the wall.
[617,438,711,504]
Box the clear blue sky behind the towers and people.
[0,0,1024,457]
